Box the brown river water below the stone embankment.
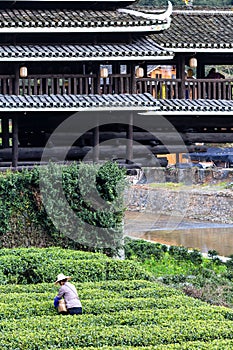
[125,211,233,256]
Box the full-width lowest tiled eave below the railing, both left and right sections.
[0,93,233,115]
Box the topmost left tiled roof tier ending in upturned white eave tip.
[0,9,170,33]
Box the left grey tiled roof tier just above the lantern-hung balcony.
[0,38,173,61]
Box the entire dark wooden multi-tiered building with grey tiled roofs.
[0,0,233,168]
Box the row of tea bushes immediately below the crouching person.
[1,305,233,331]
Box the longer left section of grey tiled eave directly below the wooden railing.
[0,93,158,112]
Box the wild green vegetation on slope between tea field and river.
[125,239,233,308]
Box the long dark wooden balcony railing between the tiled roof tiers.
[0,74,233,100]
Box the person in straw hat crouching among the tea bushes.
[54,273,82,315]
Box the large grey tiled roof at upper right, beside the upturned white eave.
[149,10,233,52]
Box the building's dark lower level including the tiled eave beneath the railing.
[0,94,233,167]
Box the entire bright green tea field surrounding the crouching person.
[0,248,233,350]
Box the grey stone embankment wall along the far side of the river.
[125,184,233,224]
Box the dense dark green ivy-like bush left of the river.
[0,162,126,254]
